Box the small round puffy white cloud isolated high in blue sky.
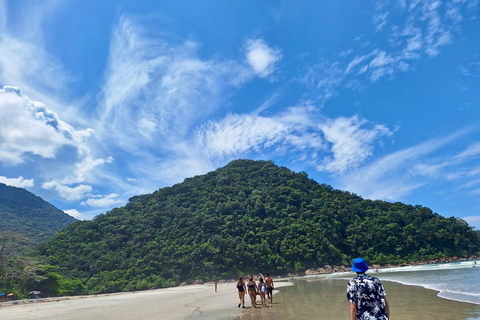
[246,39,282,77]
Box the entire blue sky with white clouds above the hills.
[0,0,480,229]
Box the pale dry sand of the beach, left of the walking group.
[0,282,290,320]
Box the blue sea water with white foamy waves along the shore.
[344,261,480,305]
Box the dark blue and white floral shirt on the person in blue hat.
[347,274,388,320]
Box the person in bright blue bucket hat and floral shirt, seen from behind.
[347,258,390,320]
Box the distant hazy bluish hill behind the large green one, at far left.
[0,183,76,252]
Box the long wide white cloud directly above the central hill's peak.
[196,107,392,174]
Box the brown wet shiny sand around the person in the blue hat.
[228,278,480,320]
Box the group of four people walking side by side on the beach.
[236,273,274,308]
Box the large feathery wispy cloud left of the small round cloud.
[97,16,255,154]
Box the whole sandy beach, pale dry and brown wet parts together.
[0,278,480,320]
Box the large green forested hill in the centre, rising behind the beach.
[41,160,479,292]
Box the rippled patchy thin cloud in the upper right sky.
[299,0,471,104]
